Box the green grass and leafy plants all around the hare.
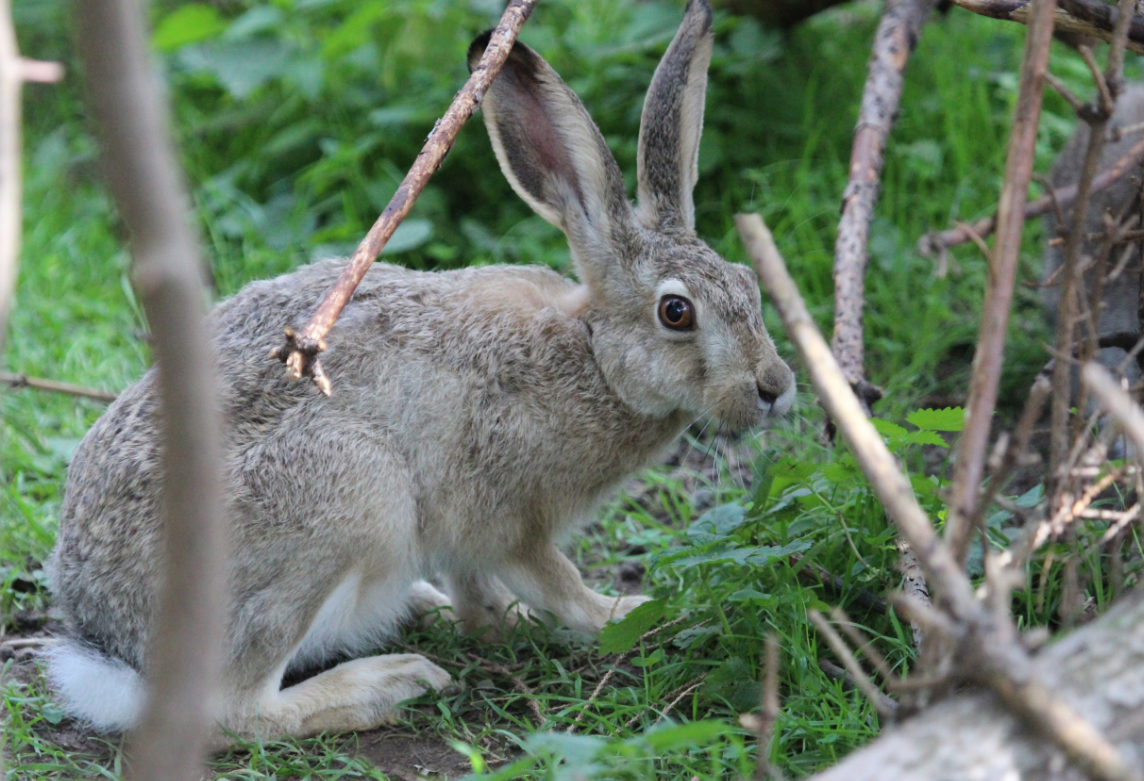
[0,0,1139,780]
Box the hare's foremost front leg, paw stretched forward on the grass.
[500,544,649,633]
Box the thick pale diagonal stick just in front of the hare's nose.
[734,214,1144,781]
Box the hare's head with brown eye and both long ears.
[469,0,794,431]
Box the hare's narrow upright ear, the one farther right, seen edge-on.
[636,0,714,231]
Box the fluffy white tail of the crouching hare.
[43,640,146,732]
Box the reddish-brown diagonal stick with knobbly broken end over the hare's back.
[279,0,537,396]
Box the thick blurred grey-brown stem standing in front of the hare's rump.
[77,0,227,781]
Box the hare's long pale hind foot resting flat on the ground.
[225,654,451,738]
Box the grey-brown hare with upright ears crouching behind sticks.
[48,0,795,743]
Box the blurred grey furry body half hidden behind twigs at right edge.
[1043,83,1144,383]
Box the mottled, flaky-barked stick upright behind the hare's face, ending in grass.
[831,0,937,409]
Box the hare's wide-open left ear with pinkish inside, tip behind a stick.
[469,31,631,284]
